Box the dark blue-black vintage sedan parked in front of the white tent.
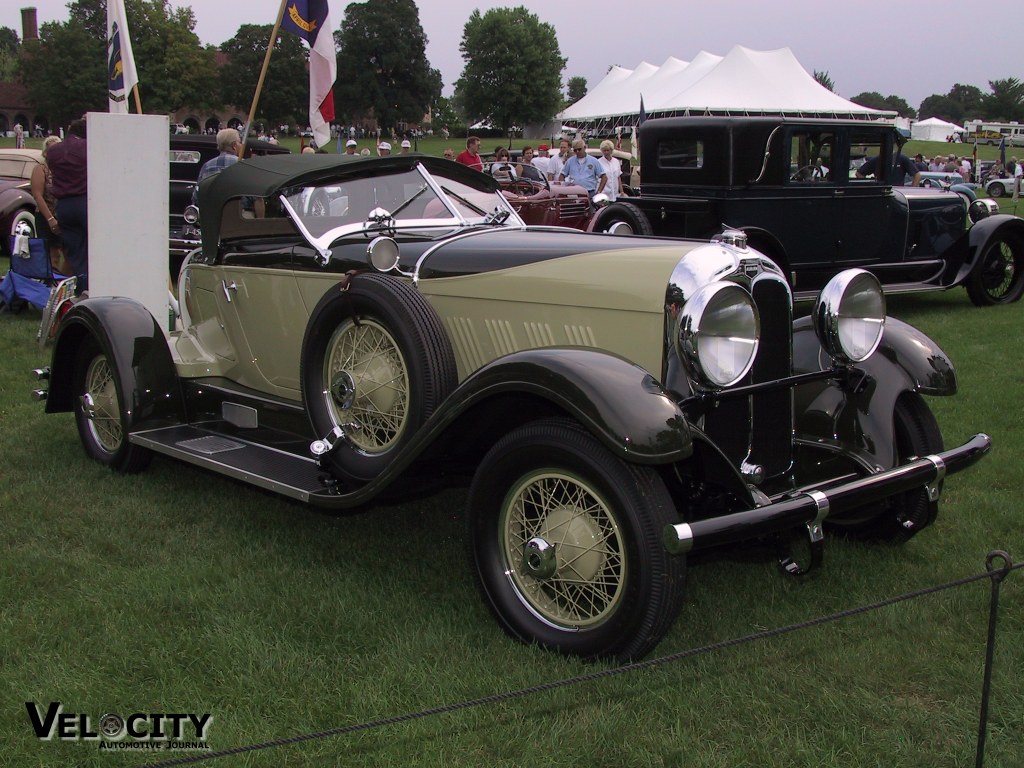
[594,117,1024,305]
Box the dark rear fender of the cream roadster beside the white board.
[46,297,185,426]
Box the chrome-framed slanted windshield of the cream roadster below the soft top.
[284,166,522,241]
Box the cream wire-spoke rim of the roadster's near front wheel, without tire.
[501,471,627,627]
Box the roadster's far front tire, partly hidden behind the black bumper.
[837,392,942,544]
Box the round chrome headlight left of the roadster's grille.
[677,281,761,388]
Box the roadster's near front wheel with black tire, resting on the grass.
[468,420,686,659]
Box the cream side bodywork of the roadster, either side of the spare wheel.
[172,244,692,393]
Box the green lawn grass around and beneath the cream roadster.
[0,260,1024,768]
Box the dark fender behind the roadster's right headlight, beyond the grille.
[793,317,956,471]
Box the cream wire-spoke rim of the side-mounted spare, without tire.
[324,319,410,454]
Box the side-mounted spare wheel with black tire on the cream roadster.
[300,272,458,482]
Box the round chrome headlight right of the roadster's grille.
[813,269,886,362]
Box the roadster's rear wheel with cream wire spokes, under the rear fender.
[75,339,153,473]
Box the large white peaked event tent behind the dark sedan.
[558,45,895,131]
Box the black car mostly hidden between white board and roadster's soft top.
[168,133,289,278]
